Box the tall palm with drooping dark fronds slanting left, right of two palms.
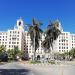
[42,21,61,59]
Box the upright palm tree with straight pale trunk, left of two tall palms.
[29,18,43,60]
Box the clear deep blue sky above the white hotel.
[0,0,75,33]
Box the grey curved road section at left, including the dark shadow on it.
[0,62,32,75]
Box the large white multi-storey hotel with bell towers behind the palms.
[0,18,75,58]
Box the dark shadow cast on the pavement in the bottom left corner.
[0,69,29,75]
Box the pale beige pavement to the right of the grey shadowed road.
[22,64,75,75]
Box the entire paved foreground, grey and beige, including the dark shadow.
[0,62,75,75]
